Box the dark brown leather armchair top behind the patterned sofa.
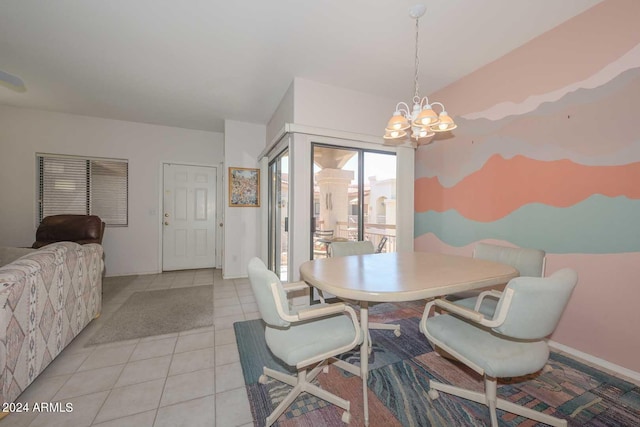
[31,215,105,249]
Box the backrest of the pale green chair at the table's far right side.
[473,243,545,277]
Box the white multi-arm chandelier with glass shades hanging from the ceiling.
[384,4,457,145]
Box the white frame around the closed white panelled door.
[159,160,224,273]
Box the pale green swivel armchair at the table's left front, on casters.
[248,258,362,426]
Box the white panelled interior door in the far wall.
[162,164,217,271]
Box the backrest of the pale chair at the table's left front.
[247,257,289,328]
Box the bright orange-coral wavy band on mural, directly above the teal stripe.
[415,154,640,222]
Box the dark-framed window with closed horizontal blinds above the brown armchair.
[37,154,129,225]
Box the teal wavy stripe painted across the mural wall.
[414,195,640,254]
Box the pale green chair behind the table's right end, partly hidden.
[447,243,545,317]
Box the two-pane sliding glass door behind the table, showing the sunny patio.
[311,144,396,259]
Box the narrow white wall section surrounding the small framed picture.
[222,120,267,279]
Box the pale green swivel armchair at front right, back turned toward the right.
[420,268,578,427]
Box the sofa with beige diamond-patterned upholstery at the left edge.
[0,242,104,406]
